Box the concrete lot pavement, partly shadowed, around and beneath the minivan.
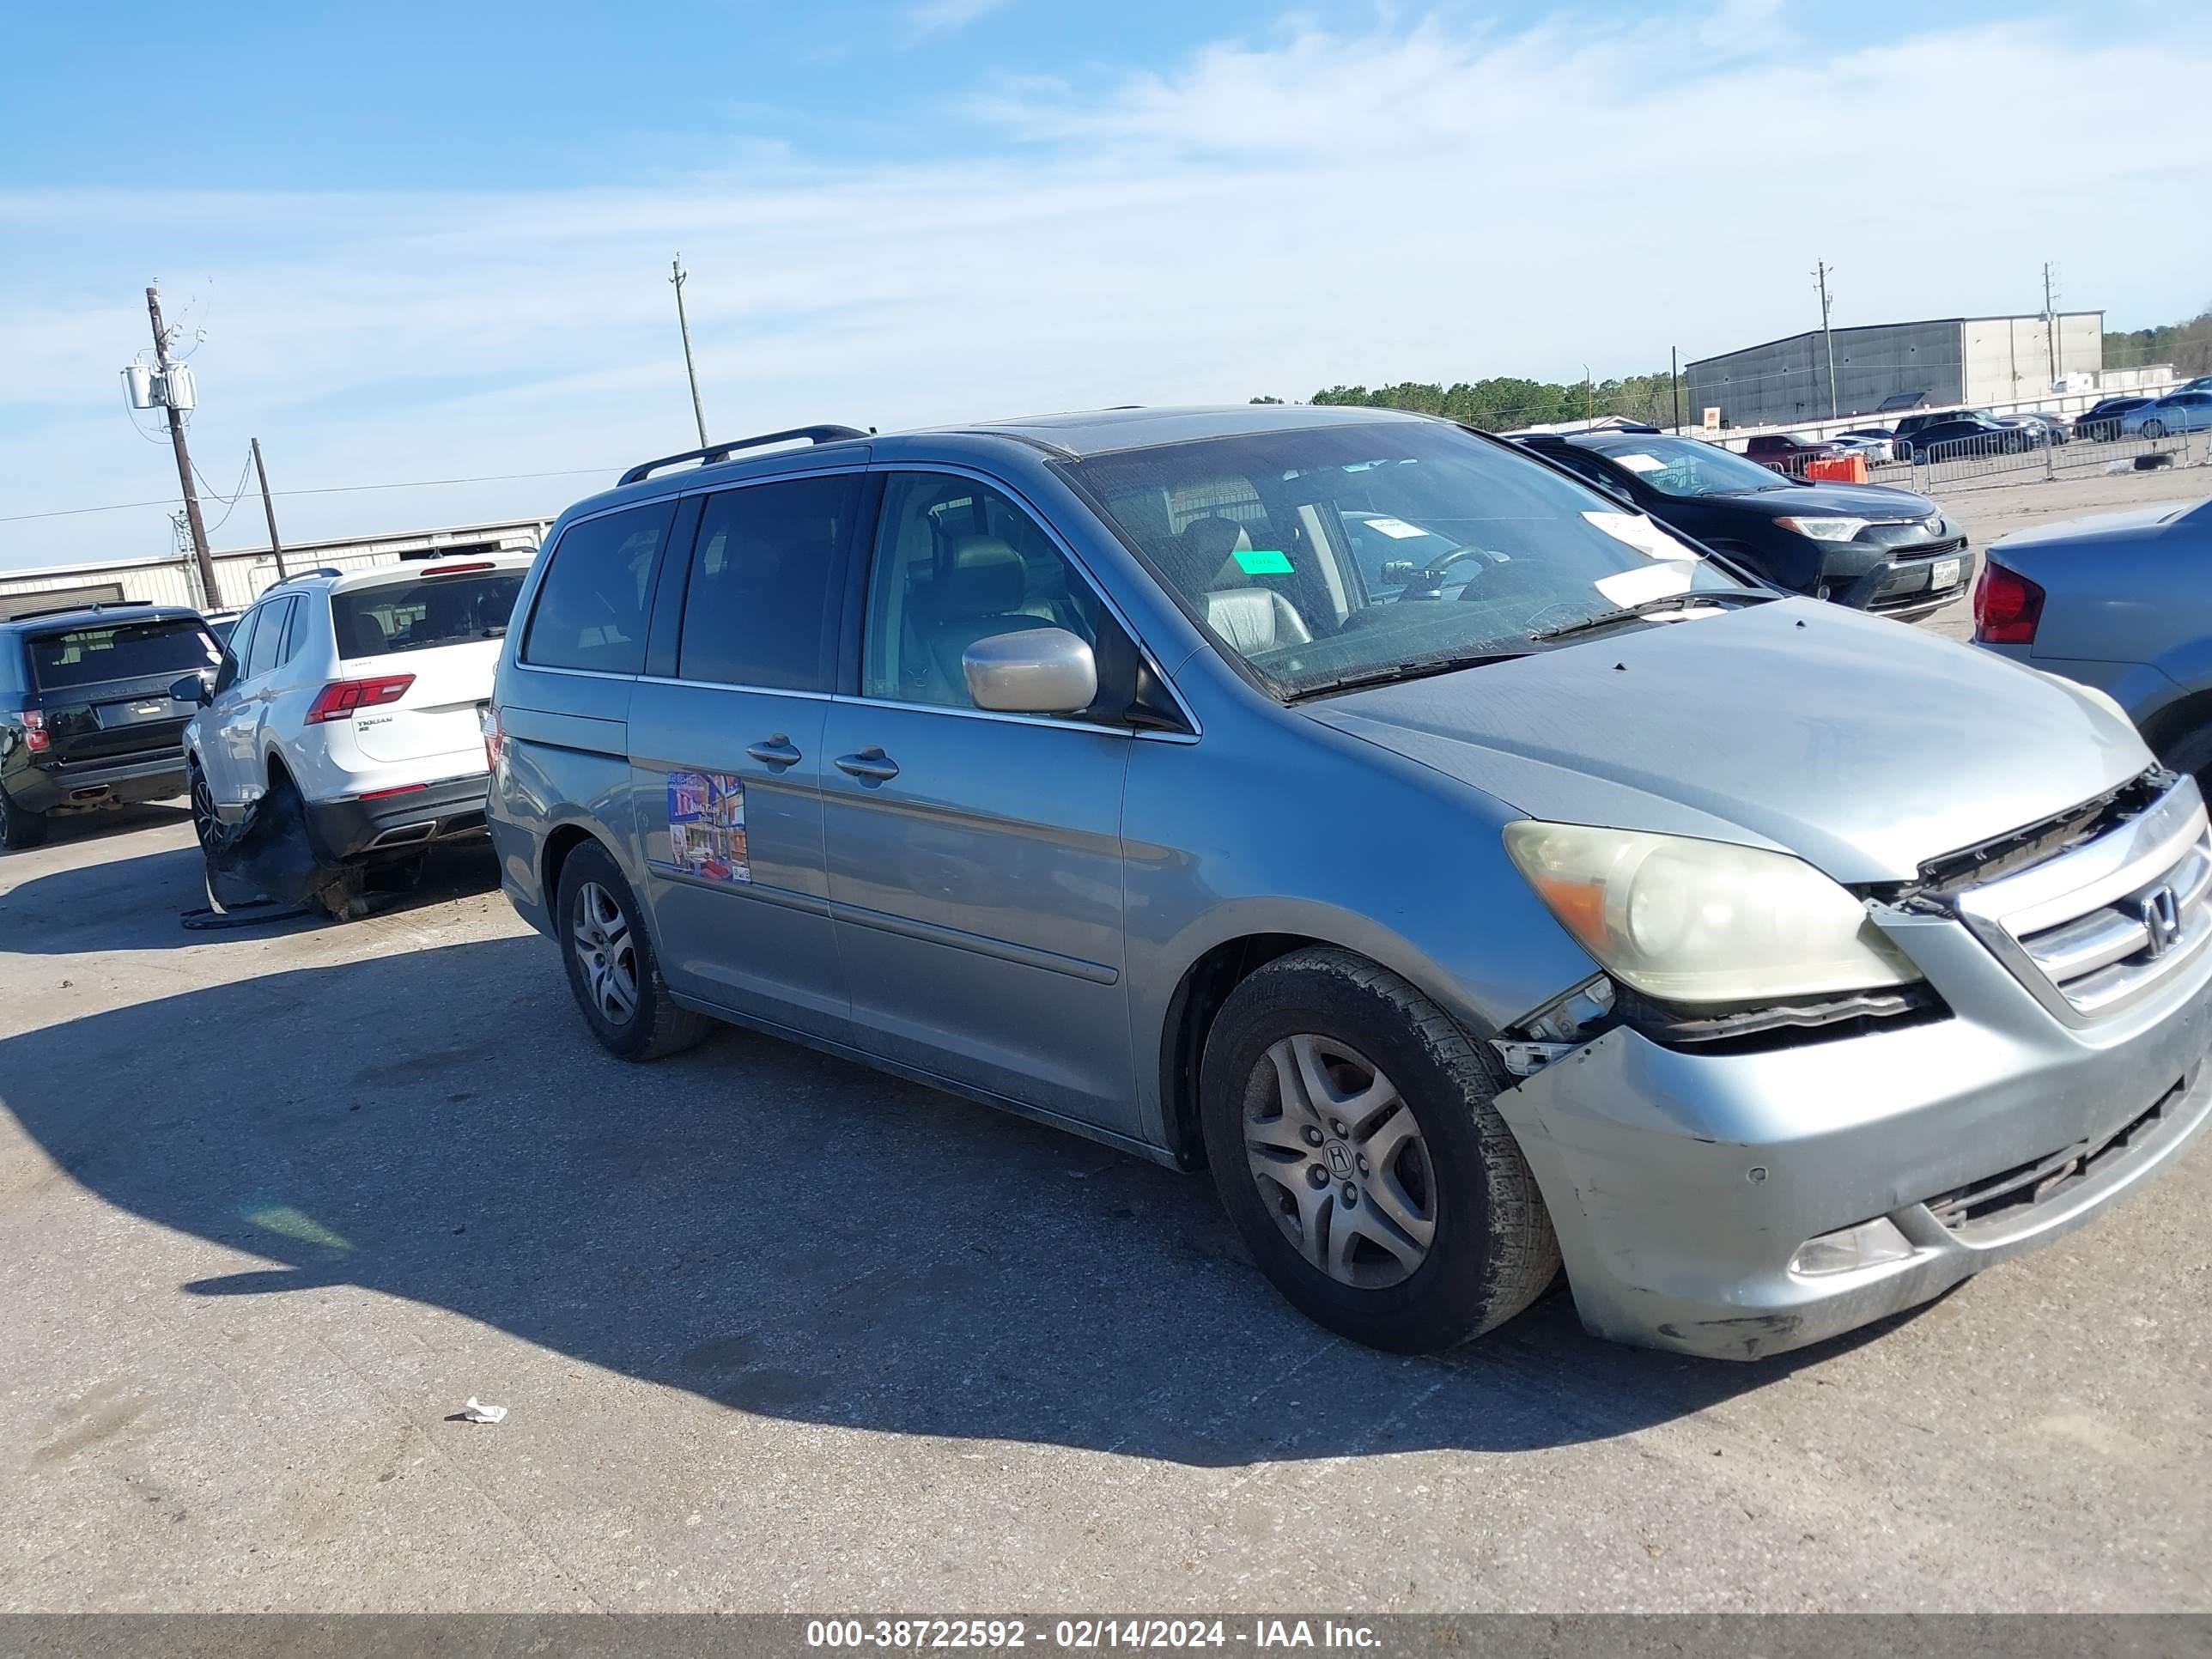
[0,462,2212,1613]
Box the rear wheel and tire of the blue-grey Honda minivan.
[556,841,714,1060]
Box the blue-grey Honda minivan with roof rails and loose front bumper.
[484,407,2212,1358]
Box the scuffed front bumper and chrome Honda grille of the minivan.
[1498,779,2212,1360]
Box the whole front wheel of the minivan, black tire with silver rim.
[1199,949,1559,1354]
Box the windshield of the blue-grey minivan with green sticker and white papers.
[1068,422,1754,696]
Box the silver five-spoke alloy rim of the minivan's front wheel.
[1245,1033,1437,1290]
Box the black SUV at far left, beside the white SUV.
[0,602,223,848]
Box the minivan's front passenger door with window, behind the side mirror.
[821,473,1137,1134]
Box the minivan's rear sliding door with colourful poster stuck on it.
[630,471,865,1040]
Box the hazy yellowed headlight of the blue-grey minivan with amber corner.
[1504,818,1920,1005]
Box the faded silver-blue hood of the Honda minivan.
[1301,599,2150,883]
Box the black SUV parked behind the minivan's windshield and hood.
[1520,434,1973,622]
